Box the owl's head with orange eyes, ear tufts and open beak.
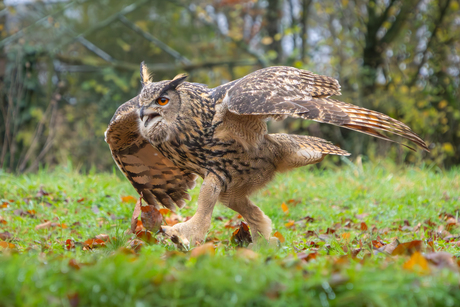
[139,62,187,145]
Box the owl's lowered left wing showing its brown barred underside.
[105,97,197,211]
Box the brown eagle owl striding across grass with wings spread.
[106,63,428,245]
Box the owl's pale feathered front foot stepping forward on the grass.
[161,221,206,250]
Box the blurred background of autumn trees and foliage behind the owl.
[0,0,460,172]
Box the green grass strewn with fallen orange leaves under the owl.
[0,162,460,306]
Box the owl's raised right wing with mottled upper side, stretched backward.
[215,66,429,151]
